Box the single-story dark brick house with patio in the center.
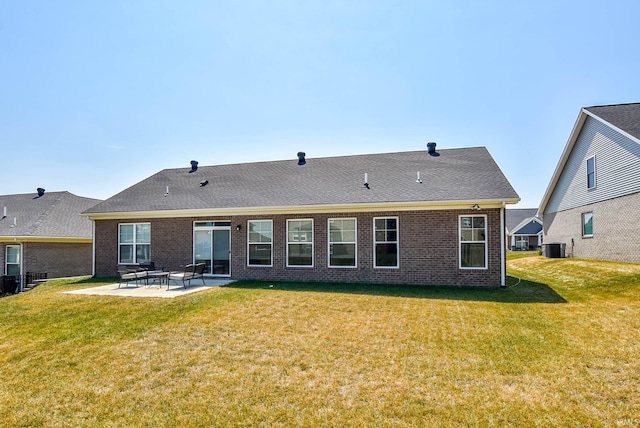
[83,143,519,286]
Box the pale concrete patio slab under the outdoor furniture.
[64,279,233,299]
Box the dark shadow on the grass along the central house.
[225,277,567,303]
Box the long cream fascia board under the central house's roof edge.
[82,198,520,220]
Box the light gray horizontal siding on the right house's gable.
[545,117,640,213]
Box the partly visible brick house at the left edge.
[0,189,100,284]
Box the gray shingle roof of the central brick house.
[84,147,518,215]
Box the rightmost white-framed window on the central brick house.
[459,215,487,269]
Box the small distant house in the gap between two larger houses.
[506,208,542,250]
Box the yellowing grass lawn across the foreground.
[0,255,640,427]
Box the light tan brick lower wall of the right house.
[543,193,640,263]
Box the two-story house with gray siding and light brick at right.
[539,103,640,263]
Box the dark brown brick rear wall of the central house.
[96,209,502,286]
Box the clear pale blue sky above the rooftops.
[0,0,640,208]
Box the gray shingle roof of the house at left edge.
[0,192,100,238]
